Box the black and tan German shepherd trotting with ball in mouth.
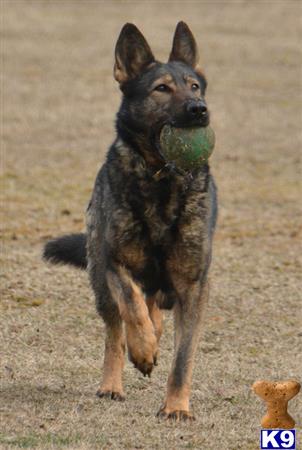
[44,22,217,420]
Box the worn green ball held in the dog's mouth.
[160,125,215,171]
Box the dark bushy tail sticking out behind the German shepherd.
[43,233,87,269]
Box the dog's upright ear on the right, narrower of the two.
[169,22,198,69]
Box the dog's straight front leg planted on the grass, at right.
[158,280,208,420]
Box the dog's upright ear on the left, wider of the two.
[114,23,155,84]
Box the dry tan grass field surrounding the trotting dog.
[0,0,302,450]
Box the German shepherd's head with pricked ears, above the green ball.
[114,22,209,162]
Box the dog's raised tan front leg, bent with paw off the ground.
[107,268,158,376]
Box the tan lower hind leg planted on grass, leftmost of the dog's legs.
[97,319,125,401]
